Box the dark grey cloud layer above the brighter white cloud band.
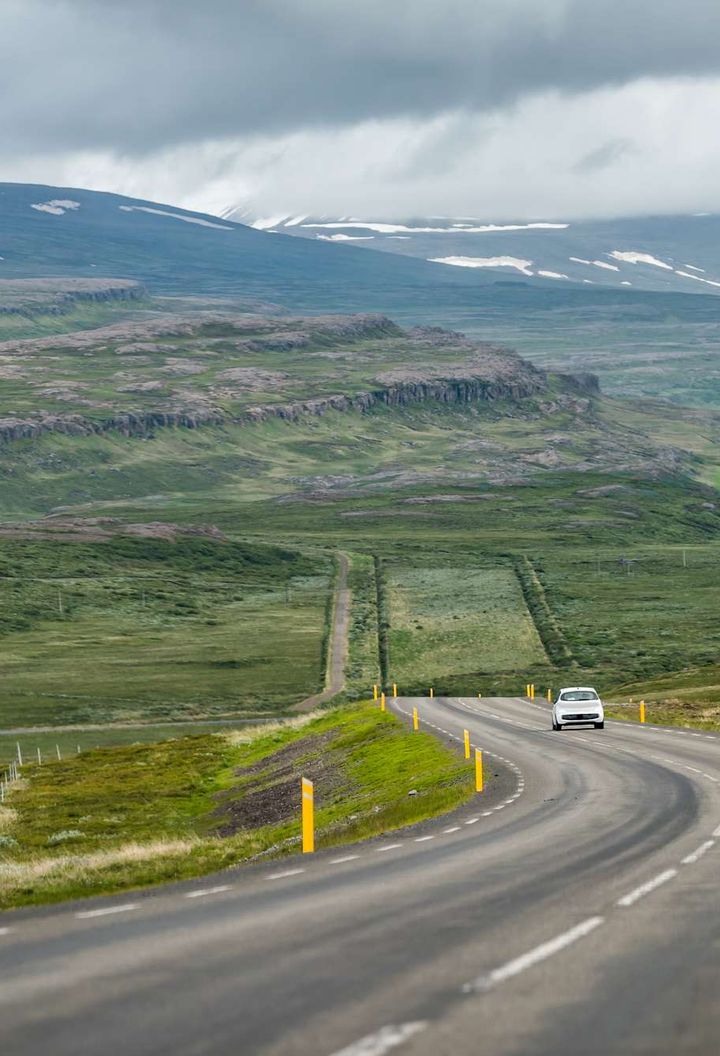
[0,0,720,154]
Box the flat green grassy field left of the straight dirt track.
[0,538,331,729]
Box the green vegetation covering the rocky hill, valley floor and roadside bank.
[0,295,720,904]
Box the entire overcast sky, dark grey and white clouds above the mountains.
[0,0,720,219]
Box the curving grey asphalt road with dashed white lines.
[0,698,720,1056]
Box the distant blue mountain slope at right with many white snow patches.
[224,206,720,295]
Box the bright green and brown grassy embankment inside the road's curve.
[0,704,474,908]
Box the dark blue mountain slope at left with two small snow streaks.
[0,184,532,309]
